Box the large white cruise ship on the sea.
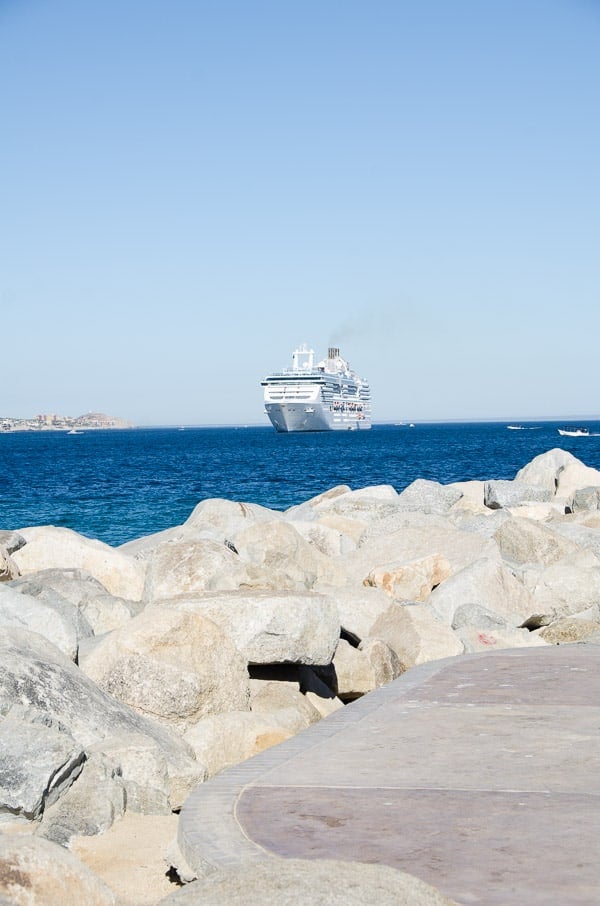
[261,346,371,432]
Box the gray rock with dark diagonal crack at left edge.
[0,716,85,820]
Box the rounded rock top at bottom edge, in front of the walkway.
[159,856,456,906]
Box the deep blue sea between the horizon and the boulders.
[0,421,600,545]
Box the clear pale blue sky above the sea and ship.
[0,0,600,425]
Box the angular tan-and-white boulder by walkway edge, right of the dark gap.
[371,604,464,671]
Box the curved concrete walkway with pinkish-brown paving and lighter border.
[178,644,600,906]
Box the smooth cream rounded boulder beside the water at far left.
[12,525,145,601]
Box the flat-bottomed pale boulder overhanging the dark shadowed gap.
[171,591,340,660]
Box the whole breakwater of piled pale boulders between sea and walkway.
[0,449,600,906]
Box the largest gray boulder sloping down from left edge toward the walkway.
[0,627,204,808]
